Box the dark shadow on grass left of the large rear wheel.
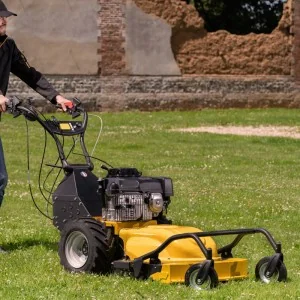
[1,239,58,252]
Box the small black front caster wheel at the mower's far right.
[255,257,287,283]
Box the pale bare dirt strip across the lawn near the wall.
[174,126,300,139]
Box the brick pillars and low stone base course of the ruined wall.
[9,0,300,111]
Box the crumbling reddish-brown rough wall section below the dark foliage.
[132,0,292,75]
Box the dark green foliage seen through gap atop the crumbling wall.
[187,0,286,34]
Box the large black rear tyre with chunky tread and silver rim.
[58,219,111,274]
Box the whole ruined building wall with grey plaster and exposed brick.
[10,0,300,111]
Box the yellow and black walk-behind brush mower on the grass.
[8,98,287,290]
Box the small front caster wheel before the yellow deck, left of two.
[185,264,219,290]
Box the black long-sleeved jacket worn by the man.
[0,35,59,104]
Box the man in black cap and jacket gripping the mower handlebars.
[0,0,72,248]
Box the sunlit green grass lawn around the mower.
[0,109,300,300]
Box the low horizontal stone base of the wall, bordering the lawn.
[10,75,300,111]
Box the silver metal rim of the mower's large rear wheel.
[65,231,89,269]
